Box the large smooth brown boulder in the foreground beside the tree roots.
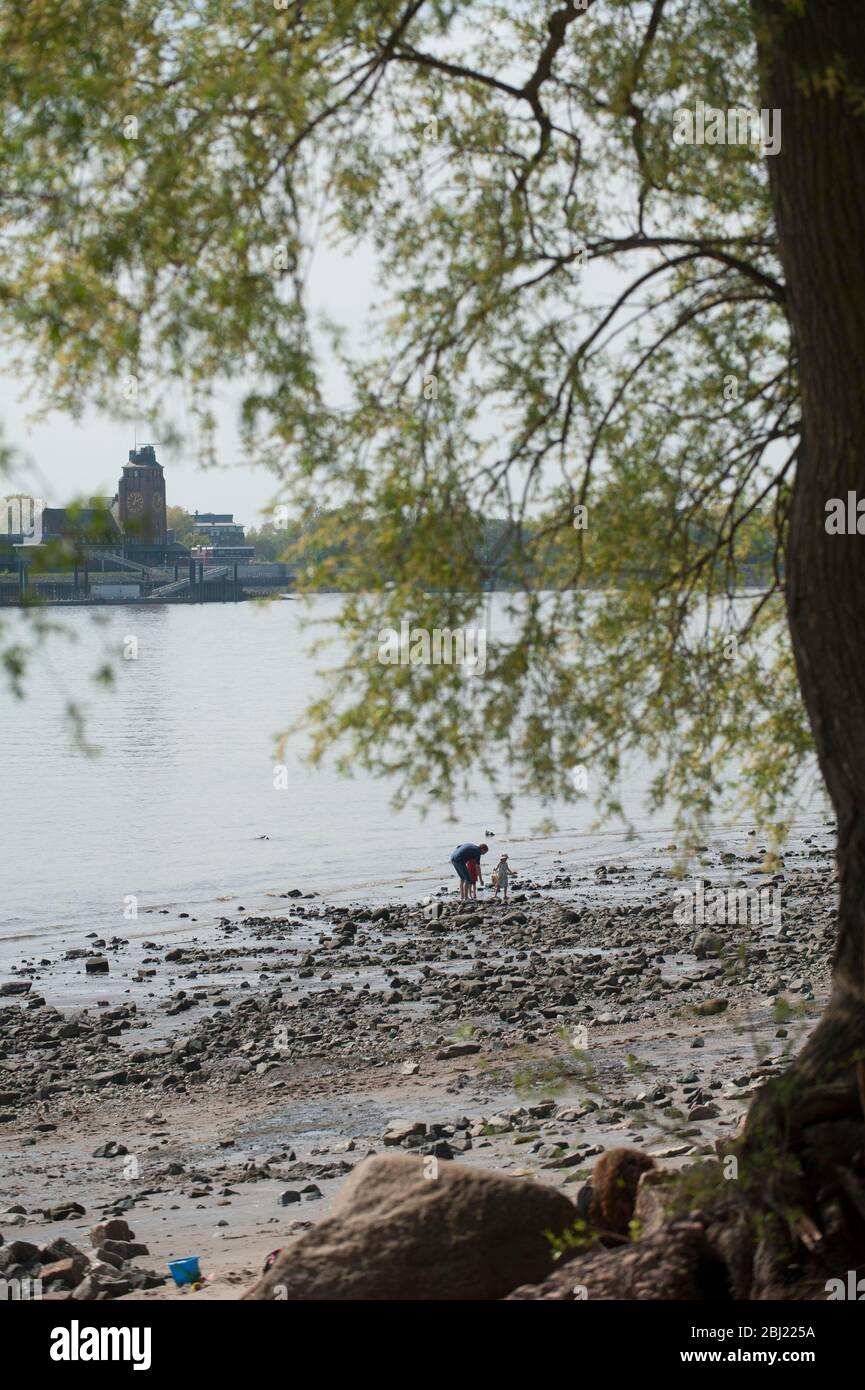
[243,1154,576,1301]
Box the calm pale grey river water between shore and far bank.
[0,595,823,949]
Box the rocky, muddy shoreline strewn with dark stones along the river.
[0,835,836,1298]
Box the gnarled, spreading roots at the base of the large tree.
[509,1034,865,1302]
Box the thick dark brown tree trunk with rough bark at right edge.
[752,0,865,1127]
